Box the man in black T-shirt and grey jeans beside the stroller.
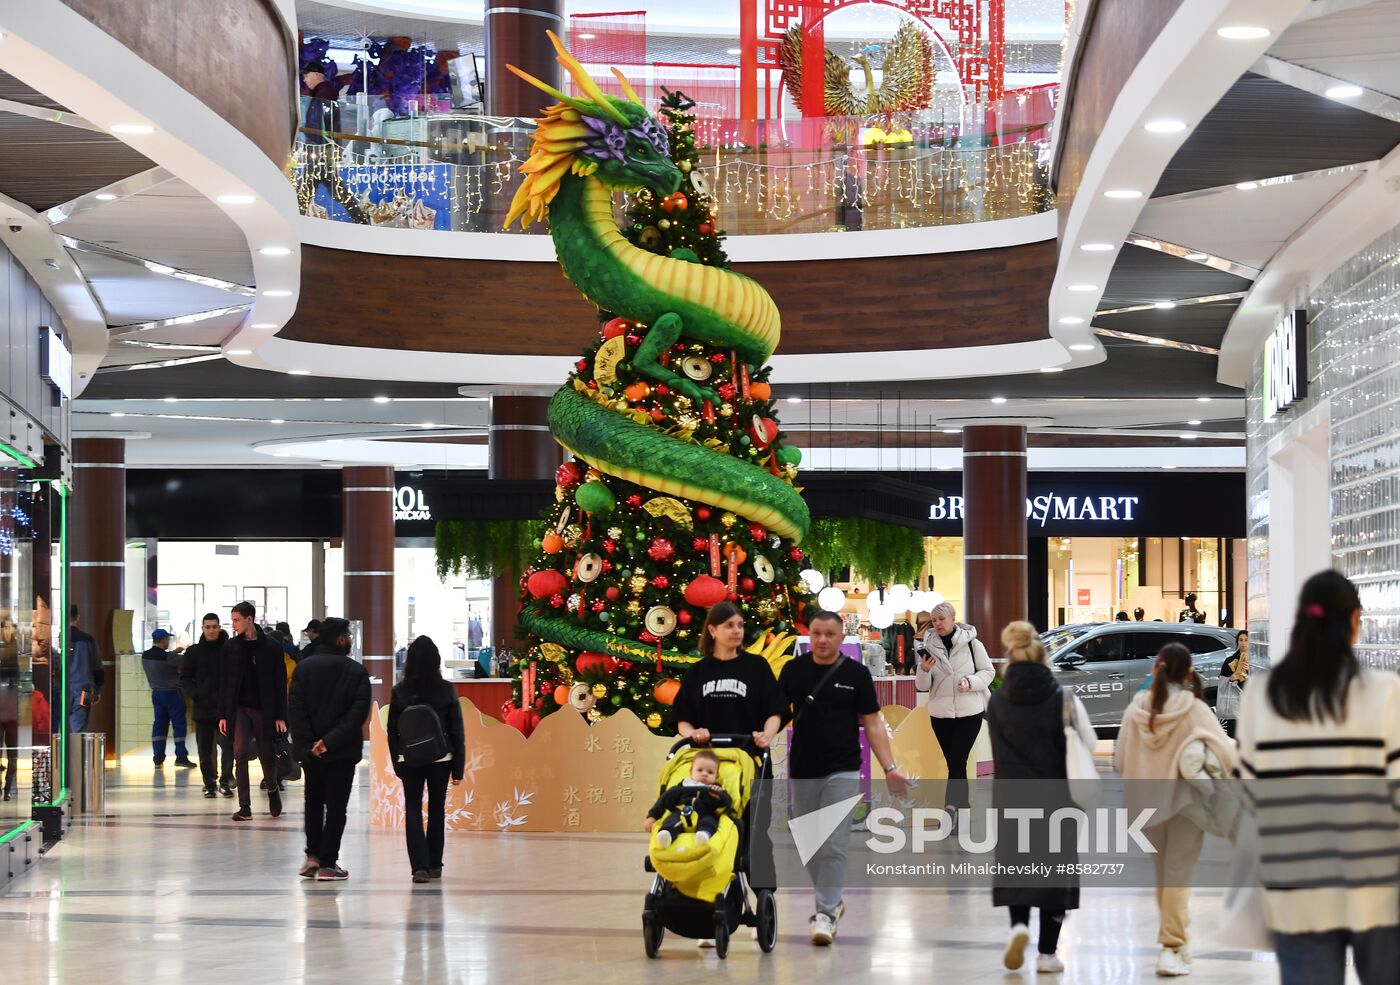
[778,613,907,947]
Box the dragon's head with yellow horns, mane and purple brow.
[505,31,685,227]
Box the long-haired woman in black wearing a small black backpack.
[388,637,466,883]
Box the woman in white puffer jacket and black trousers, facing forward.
[914,602,997,817]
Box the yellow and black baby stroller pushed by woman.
[641,736,778,958]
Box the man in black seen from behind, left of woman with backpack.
[288,618,370,880]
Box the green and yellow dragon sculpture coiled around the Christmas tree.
[505,34,809,540]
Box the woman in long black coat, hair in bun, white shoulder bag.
[987,623,1095,974]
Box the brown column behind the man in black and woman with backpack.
[343,466,393,707]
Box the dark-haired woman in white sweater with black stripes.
[1239,571,1400,985]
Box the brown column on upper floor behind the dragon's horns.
[486,0,567,118]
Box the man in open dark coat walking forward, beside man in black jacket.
[218,602,287,821]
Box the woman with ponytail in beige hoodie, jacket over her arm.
[1114,644,1239,978]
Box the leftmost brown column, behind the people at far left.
[69,438,124,763]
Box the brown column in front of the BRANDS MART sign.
[963,424,1044,666]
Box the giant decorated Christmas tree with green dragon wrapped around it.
[508,42,809,732]
